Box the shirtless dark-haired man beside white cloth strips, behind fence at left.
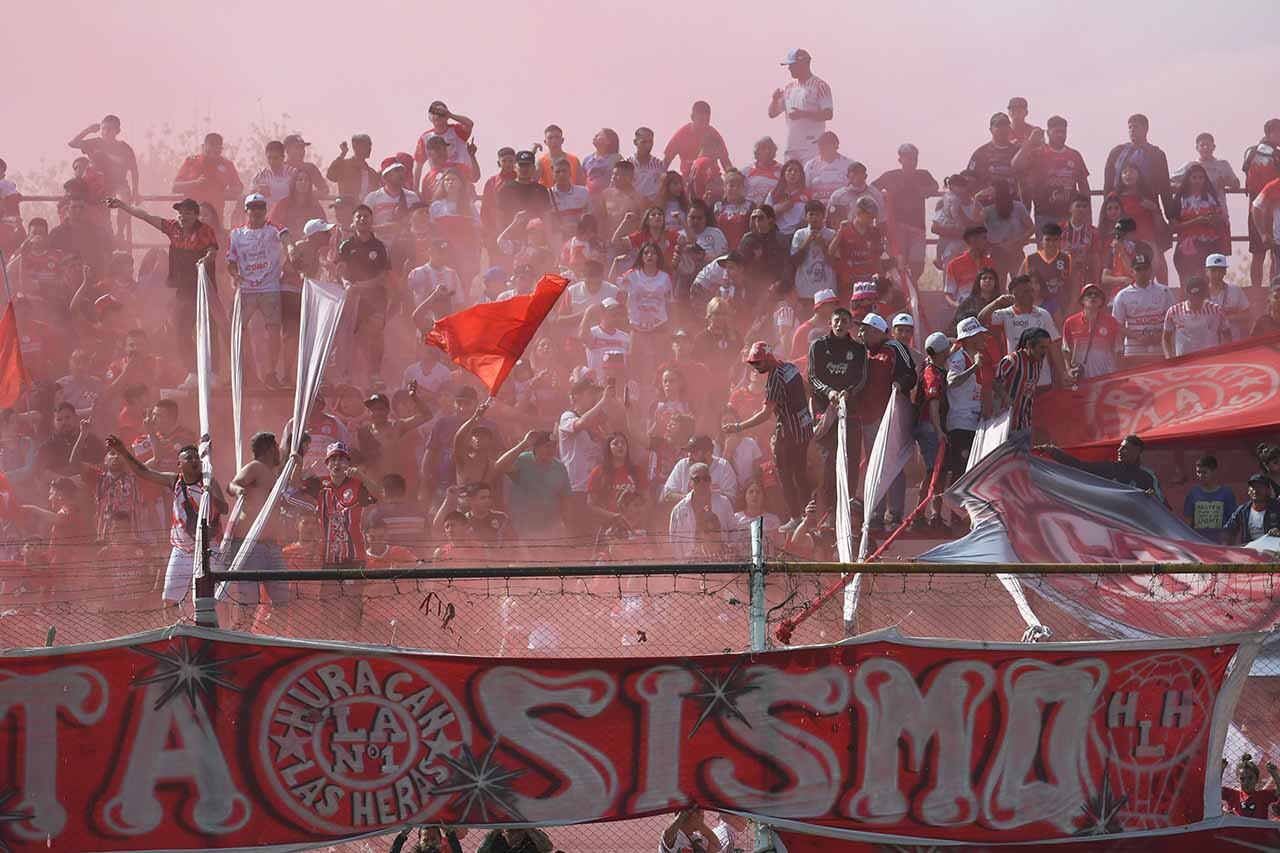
[218,433,289,625]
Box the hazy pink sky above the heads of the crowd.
[10,0,1280,192]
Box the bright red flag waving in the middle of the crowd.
[426,275,568,394]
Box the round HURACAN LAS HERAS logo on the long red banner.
[255,654,471,835]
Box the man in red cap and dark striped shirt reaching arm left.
[724,341,813,533]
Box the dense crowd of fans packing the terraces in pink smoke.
[0,50,1280,617]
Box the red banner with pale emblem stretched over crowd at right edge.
[1036,336,1280,450]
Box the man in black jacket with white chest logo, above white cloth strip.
[809,307,867,510]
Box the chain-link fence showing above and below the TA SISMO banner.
[0,543,1280,853]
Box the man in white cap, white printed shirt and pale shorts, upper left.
[227,192,285,388]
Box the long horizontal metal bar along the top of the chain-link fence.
[209,561,1280,583]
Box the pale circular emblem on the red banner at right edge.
[1087,362,1280,435]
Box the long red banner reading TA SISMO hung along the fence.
[0,626,1258,853]
